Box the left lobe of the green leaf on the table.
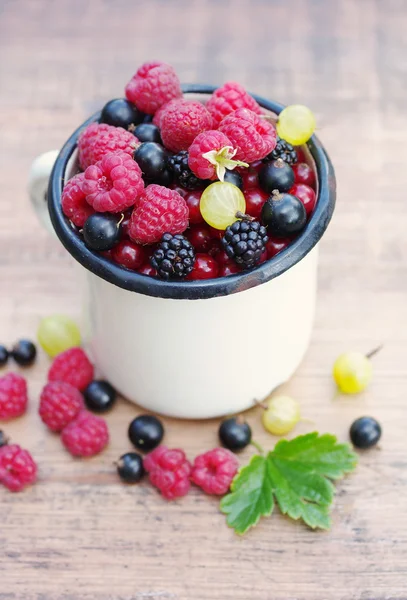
[220,455,274,534]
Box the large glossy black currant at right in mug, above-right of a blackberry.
[261,193,307,238]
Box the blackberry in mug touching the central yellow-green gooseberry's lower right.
[222,217,268,269]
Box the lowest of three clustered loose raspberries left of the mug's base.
[61,410,109,457]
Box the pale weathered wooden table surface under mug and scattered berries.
[0,0,407,600]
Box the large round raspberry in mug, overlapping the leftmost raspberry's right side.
[82,152,144,213]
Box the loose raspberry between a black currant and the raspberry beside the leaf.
[144,446,191,500]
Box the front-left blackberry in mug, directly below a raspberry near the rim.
[150,233,195,280]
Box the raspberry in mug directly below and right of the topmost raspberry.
[161,101,212,152]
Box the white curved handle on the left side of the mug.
[28,150,59,235]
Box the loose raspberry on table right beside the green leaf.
[191,448,239,496]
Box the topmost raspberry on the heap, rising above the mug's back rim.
[125,61,182,115]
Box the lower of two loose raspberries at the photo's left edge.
[0,444,37,492]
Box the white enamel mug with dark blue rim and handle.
[30,85,335,419]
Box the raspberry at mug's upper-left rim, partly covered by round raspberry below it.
[78,123,139,170]
